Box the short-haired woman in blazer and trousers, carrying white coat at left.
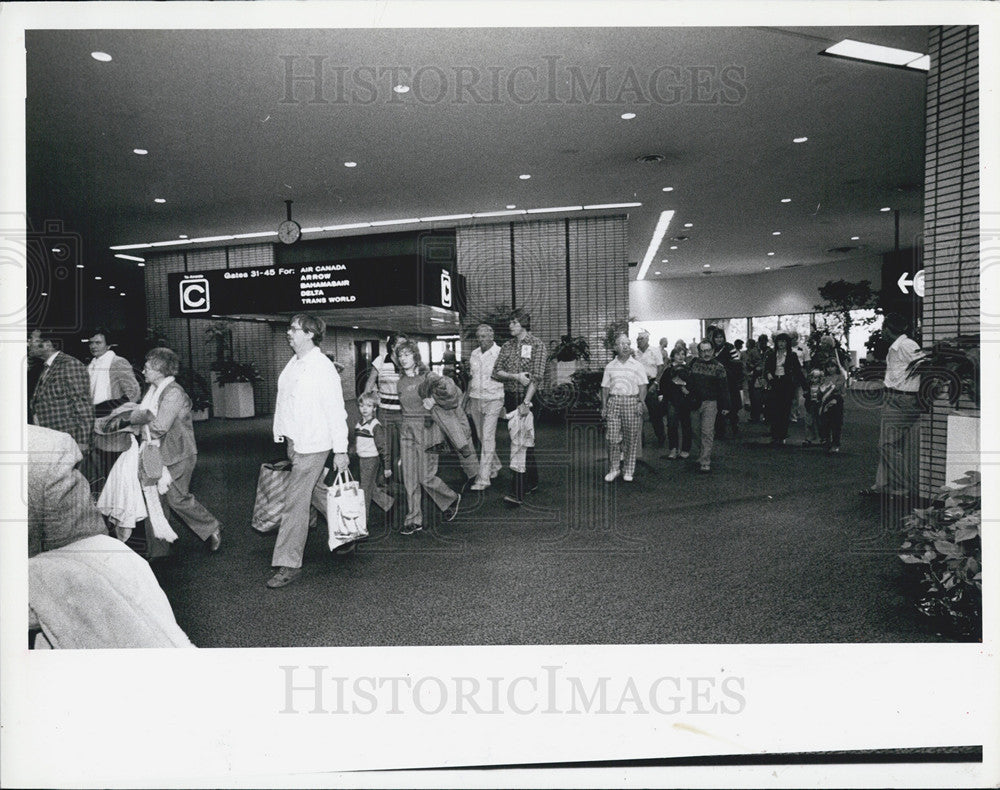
[129,347,222,551]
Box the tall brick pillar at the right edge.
[920,27,979,493]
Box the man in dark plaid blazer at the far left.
[28,329,94,453]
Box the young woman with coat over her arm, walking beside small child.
[395,339,462,535]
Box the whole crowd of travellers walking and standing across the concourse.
[28,310,919,608]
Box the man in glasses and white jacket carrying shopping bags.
[267,314,348,588]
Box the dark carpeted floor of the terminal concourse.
[145,403,943,647]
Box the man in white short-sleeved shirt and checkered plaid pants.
[601,335,648,483]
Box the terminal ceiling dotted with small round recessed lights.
[26,27,927,284]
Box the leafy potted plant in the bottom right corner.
[899,472,983,637]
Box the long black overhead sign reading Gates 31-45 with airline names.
[167,255,460,318]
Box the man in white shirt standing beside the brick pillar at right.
[862,313,923,496]
